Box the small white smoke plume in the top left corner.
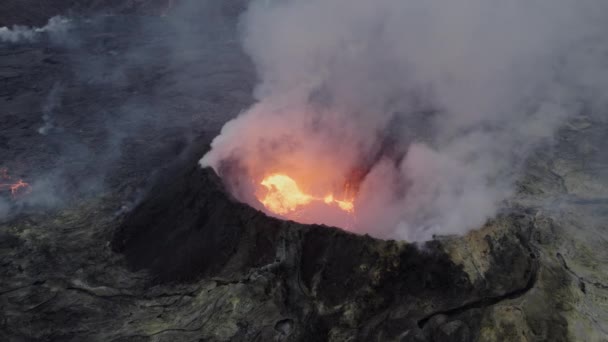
[0,16,71,43]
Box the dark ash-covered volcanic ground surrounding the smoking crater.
[0,1,608,341]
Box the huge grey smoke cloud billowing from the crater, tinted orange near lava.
[201,0,608,240]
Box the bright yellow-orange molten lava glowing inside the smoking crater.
[258,173,355,215]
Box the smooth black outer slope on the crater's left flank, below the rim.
[113,144,280,280]
